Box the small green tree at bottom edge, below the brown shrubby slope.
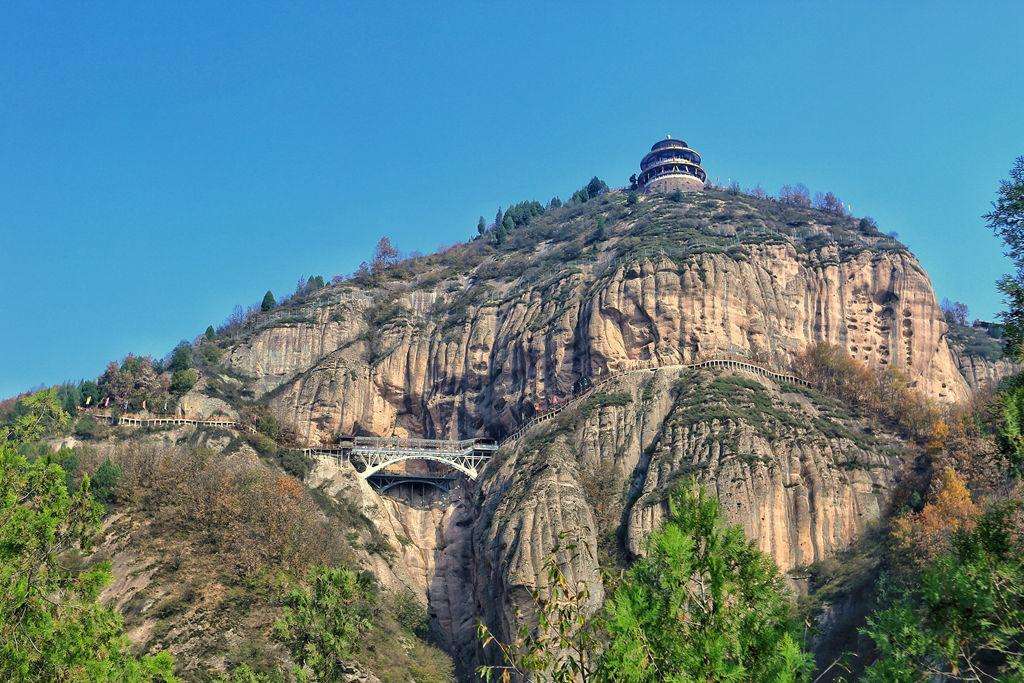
[274,567,376,681]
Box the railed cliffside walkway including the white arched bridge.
[93,357,811,493]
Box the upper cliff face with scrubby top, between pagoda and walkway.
[216,188,969,441]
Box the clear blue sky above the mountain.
[0,1,1024,395]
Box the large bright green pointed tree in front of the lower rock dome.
[601,484,811,682]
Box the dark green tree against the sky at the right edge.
[984,157,1024,360]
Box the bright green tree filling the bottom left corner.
[0,443,175,682]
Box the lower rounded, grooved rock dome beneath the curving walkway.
[419,371,904,675]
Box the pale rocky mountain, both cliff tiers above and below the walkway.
[58,189,1002,680]
